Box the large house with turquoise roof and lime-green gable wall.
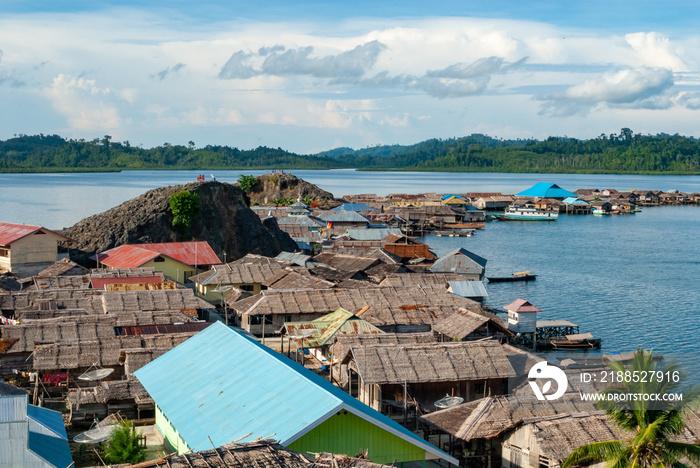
[135,322,458,465]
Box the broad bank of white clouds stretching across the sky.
[0,10,700,148]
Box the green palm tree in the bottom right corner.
[562,349,700,468]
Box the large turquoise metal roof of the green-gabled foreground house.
[135,322,457,464]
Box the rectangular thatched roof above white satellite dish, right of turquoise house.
[352,341,515,384]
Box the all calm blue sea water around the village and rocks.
[0,170,700,383]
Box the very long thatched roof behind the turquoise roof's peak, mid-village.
[228,287,479,326]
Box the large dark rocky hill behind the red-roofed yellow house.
[62,182,296,264]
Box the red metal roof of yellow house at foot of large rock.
[99,241,221,268]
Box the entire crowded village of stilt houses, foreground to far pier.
[0,173,700,468]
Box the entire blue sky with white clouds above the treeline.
[0,0,700,154]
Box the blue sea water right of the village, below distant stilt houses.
[424,206,700,383]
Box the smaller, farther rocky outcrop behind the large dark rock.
[247,172,342,210]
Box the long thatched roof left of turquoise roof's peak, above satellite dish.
[34,333,194,371]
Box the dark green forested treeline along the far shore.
[0,128,700,174]
